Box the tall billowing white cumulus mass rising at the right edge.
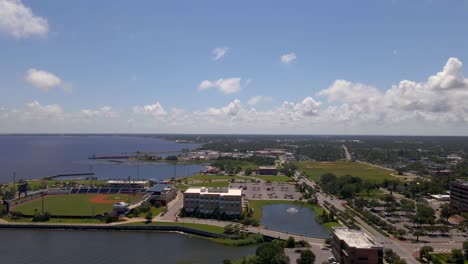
[318,58,468,124]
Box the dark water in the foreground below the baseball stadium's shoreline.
[0,230,256,264]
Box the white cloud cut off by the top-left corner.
[0,0,49,39]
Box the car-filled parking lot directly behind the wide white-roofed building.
[230,182,301,200]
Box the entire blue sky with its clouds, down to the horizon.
[0,0,468,134]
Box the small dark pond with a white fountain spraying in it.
[261,204,330,238]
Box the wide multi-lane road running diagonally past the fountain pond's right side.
[295,172,419,264]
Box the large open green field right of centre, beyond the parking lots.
[296,161,396,182]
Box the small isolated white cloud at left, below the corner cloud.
[25,68,72,92]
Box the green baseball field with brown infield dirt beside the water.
[13,194,140,216]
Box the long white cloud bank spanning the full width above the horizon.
[0,58,468,135]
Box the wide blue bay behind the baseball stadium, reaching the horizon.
[0,135,203,183]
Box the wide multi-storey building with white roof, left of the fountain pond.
[184,187,242,218]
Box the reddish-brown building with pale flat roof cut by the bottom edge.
[332,227,383,264]
